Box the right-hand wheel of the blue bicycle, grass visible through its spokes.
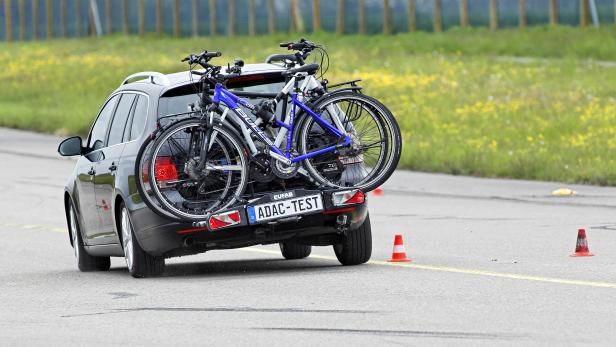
[297,92,402,191]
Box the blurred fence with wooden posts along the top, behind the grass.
[0,0,616,40]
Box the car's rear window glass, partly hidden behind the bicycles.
[158,82,284,117]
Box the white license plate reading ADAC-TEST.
[247,194,323,223]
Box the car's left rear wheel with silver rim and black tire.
[120,204,165,278]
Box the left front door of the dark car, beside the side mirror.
[76,96,118,244]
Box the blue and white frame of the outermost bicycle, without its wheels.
[213,76,351,165]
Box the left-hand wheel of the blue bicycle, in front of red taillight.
[148,119,248,221]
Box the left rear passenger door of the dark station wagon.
[93,93,135,244]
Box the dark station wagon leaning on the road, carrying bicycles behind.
[58,64,372,277]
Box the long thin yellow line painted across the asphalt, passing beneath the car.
[0,223,616,289]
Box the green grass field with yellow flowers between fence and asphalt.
[0,27,616,185]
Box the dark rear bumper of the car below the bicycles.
[132,190,368,257]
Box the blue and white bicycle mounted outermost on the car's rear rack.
[147,52,401,220]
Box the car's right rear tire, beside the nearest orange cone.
[334,215,372,265]
